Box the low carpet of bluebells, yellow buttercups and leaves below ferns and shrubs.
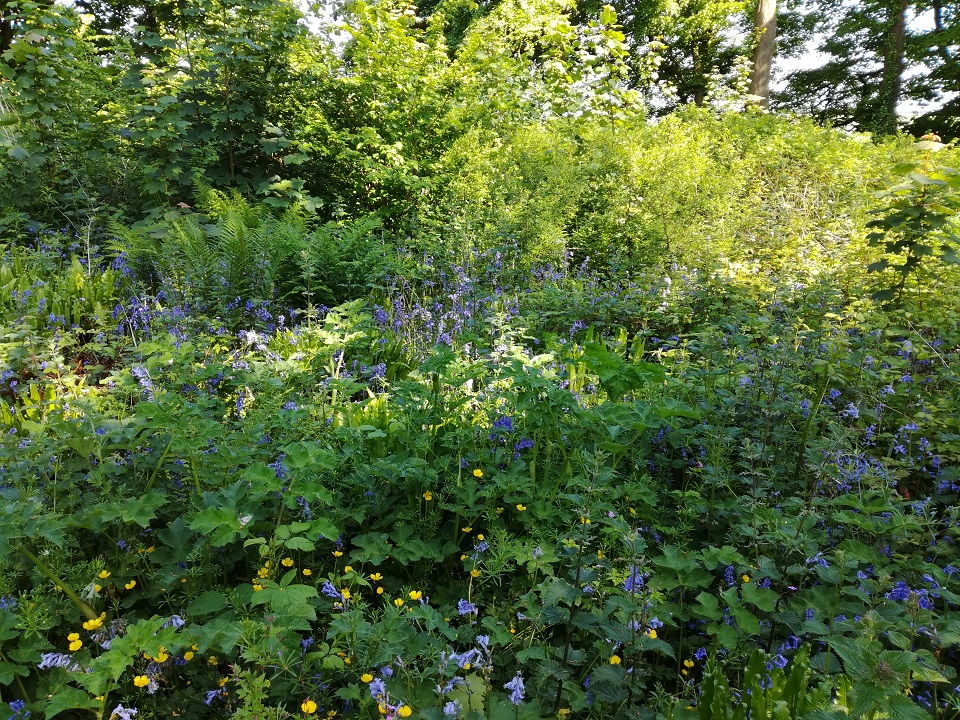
[0,221,960,718]
